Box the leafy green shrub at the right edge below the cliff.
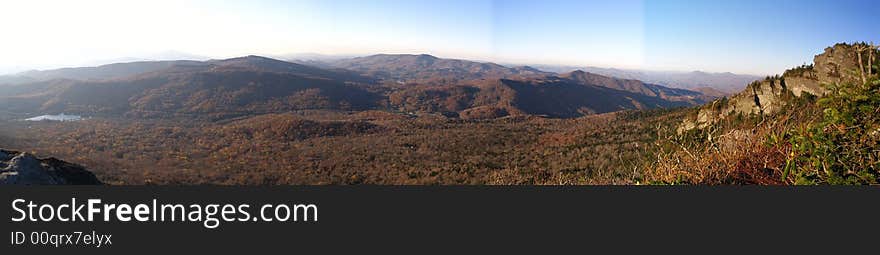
[783,77,880,184]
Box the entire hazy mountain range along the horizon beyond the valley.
[0,54,718,118]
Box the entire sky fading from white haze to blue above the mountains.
[0,0,880,74]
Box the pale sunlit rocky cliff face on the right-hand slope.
[679,44,867,131]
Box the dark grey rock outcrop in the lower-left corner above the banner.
[0,150,101,185]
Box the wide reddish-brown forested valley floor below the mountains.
[0,108,675,184]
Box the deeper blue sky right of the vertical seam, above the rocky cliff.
[644,0,880,74]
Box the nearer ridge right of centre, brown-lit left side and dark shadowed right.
[389,72,693,118]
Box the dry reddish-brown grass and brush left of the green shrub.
[644,96,821,185]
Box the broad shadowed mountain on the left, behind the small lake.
[0,57,379,116]
